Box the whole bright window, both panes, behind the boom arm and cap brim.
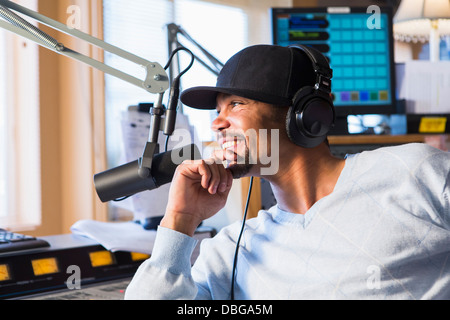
[104,0,247,170]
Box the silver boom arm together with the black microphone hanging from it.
[0,0,200,202]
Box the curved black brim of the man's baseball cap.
[180,87,292,110]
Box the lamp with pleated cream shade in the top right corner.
[394,0,450,61]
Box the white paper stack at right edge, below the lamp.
[400,61,450,114]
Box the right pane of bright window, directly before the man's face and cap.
[175,0,249,141]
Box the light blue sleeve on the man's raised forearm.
[125,227,198,300]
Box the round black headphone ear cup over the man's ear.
[286,87,335,148]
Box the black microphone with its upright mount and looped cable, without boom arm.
[94,47,197,202]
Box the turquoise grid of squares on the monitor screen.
[328,14,391,105]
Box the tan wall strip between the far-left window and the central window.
[34,0,107,235]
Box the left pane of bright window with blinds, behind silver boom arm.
[104,0,172,166]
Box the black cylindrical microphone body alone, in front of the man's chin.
[94,144,201,202]
